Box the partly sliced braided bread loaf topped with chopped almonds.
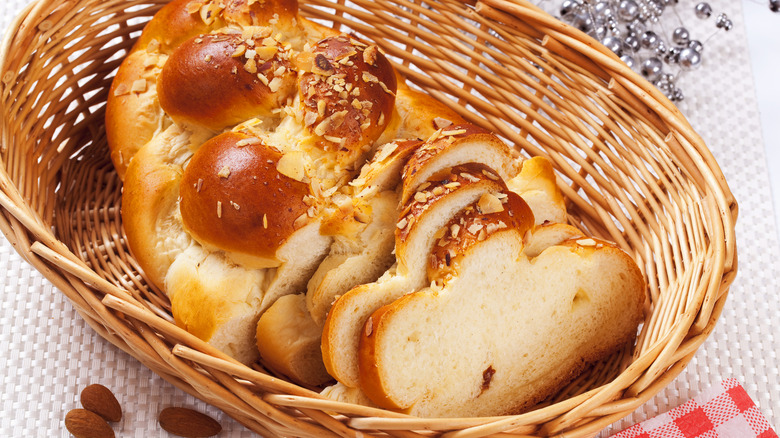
[106,0,643,415]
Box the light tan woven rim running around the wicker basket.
[0,0,738,436]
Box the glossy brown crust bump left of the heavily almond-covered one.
[157,29,297,131]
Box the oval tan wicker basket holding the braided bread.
[0,0,737,437]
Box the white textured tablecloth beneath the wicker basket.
[0,0,780,438]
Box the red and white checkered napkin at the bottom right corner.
[612,379,778,438]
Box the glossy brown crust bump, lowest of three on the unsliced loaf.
[181,132,311,266]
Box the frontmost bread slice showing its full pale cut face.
[359,217,644,417]
